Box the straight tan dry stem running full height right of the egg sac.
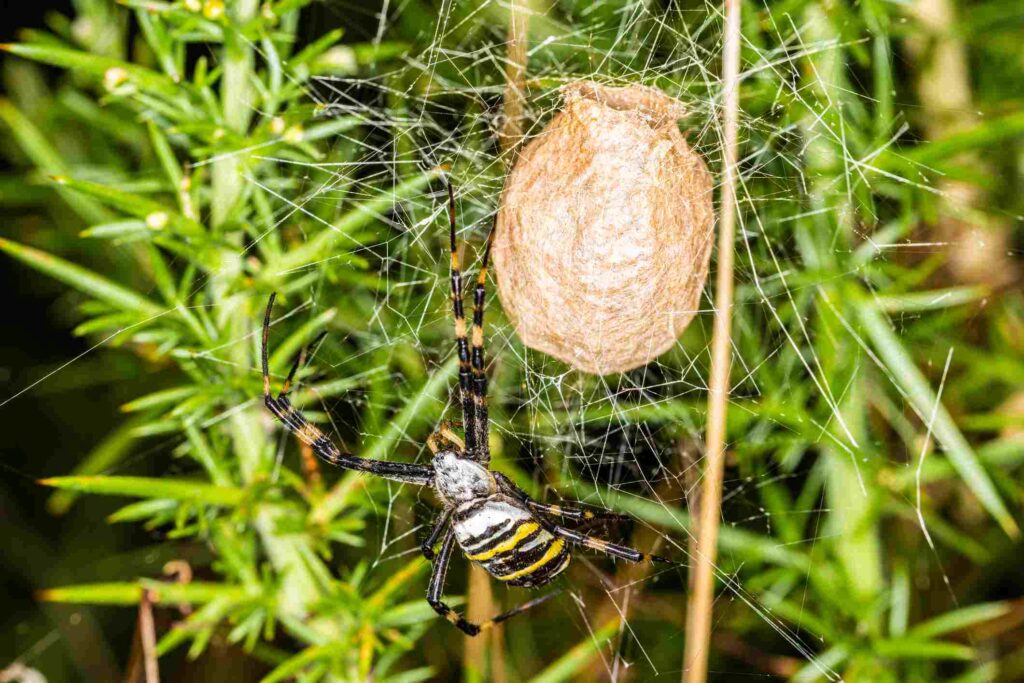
[683,0,740,683]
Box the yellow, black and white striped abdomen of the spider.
[453,496,570,587]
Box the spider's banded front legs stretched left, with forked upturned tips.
[260,294,434,485]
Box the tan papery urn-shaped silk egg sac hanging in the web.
[494,82,714,375]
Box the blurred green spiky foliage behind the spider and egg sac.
[0,0,1024,681]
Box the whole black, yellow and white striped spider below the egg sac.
[262,183,676,636]
